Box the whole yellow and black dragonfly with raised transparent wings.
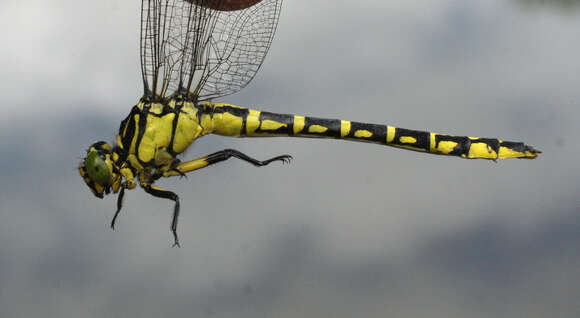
[78,0,541,246]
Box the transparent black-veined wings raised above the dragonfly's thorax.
[141,0,282,100]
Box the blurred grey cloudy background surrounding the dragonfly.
[0,0,580,317]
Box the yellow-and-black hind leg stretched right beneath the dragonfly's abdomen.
[163,149,292,177]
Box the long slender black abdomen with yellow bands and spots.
[205,104,540,160]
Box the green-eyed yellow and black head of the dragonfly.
[79,141,119,199]
